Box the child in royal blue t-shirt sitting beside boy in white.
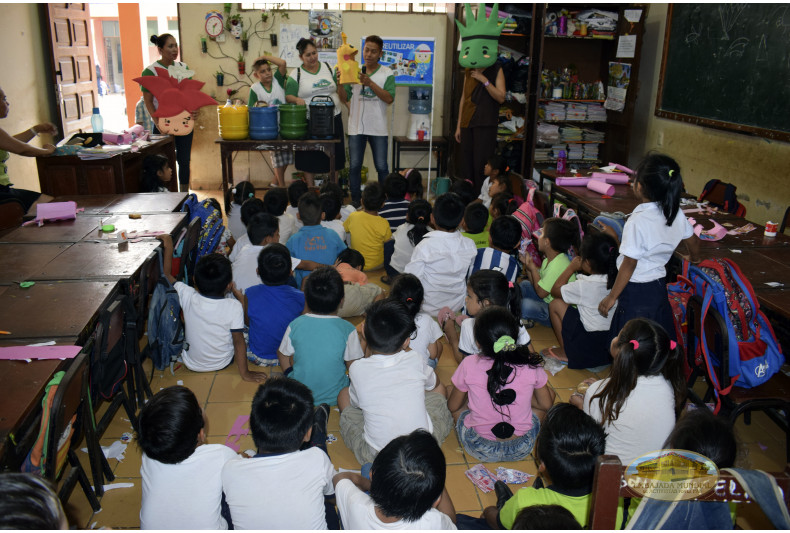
[244,242,305,366]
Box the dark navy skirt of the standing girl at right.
[609,278,677,341]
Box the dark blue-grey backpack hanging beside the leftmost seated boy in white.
[148,250,184,370]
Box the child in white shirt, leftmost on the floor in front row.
[137,385,237,529]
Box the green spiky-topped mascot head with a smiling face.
[455,4,505,68]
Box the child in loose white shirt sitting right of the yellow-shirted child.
[404,193,477,315]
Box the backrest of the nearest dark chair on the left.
[44,350,88,482]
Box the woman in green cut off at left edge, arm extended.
[0,88,58,211]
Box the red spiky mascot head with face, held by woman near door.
[134,65,217,135]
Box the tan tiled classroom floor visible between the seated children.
[60,187,785,529]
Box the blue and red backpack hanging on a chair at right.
[667,258,785,413]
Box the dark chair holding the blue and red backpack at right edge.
[686,295,790,462]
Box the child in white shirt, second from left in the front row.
[222,377,339,529]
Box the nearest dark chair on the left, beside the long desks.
[44,350,112,511]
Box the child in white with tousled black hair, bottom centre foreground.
[332,429,455,530]
